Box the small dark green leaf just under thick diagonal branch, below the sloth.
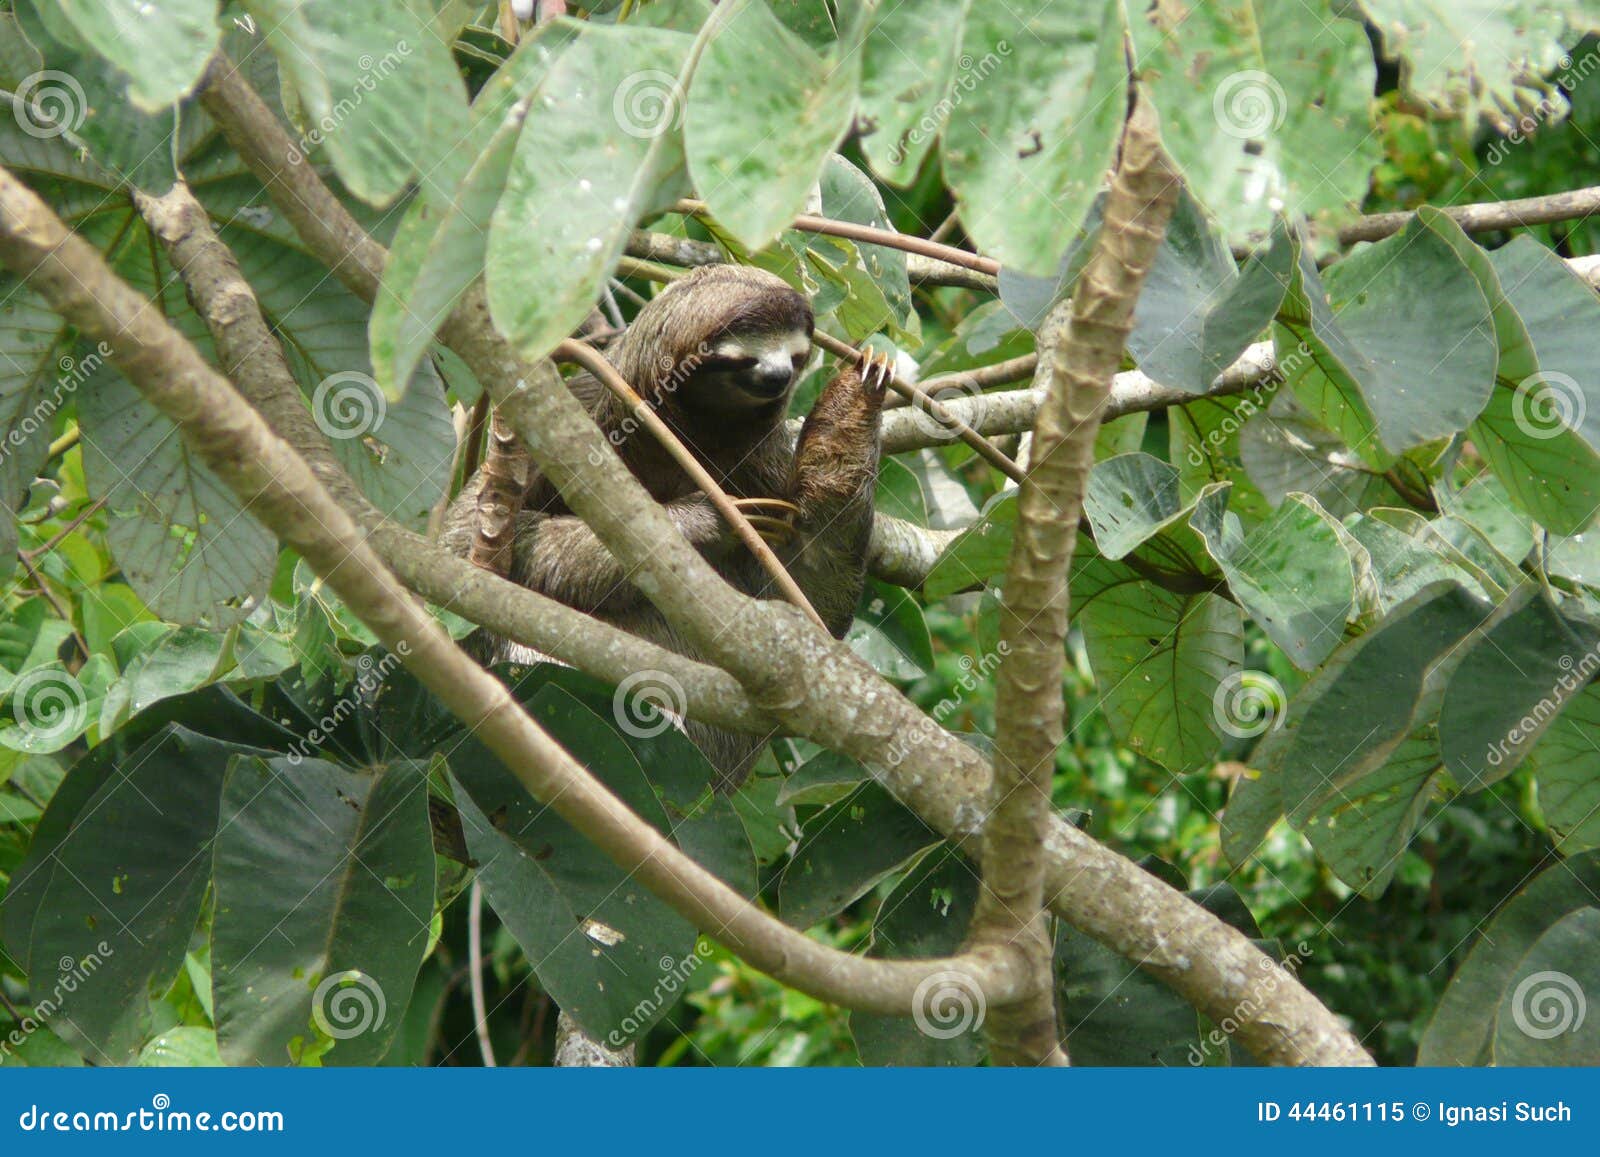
[778,783,942,928]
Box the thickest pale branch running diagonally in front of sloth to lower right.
[193,56,1371,1064]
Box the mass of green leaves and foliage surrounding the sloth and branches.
[0,0,1600,1064]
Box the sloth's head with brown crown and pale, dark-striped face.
[616,266,813,419]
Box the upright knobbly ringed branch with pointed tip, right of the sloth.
[973,99,1181,1064]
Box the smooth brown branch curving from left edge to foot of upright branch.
[0,170,1021,1015]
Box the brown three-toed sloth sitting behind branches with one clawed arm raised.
[445,266,885,791]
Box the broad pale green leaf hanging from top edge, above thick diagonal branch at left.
[245,0,467,205]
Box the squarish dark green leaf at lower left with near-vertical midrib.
[211,755,434,1064]
